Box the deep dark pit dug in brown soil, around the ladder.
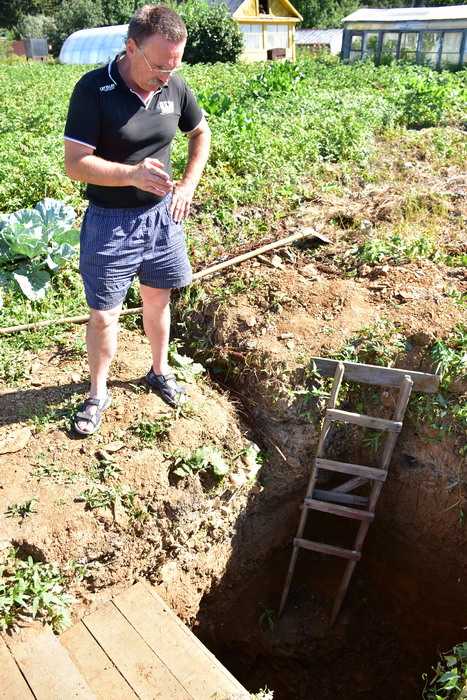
[181,370,467,700]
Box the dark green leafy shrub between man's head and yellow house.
[178,0,243,63]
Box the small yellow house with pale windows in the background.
[226,0,303,61]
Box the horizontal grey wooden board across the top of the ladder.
[311,357,439,394]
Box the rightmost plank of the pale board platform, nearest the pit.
[113,583,250,700]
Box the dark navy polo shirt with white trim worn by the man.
[65,59,203,207]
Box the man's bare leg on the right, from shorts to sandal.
[140,284,170,374]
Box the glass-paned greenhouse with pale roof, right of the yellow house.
[341,5,467,69]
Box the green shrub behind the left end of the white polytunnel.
[49,0,106,55]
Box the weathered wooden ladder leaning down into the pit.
[279,358,439,625]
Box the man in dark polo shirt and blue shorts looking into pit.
[65,5,210,435]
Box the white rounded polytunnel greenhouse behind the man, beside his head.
[58,24,128,65]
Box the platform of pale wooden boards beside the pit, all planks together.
[0,583,250,700]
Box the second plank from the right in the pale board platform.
[82,602,192,700]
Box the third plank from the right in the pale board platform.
[60,622,137,700]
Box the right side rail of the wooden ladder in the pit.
[331,375,413,625]
